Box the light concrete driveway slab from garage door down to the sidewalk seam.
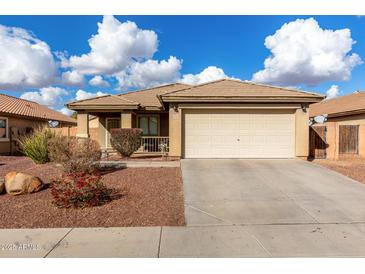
[182,160,365,225]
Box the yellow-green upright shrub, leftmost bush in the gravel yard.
[19,128,55,164]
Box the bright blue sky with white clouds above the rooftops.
[0,16,365,113]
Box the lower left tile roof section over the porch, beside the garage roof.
[67,83,189,109]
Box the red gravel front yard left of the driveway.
[0,156,184,228]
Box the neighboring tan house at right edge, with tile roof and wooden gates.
[309,92,365,160]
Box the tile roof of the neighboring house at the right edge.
[309,91,365,117]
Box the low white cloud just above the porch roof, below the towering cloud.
[116,56,182,88]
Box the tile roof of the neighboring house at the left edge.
[0,94,76,124]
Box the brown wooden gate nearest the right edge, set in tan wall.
[339,125,359,154]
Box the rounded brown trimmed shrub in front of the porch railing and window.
[110,128,142,157]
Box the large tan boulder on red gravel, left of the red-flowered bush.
[5,171,43,195]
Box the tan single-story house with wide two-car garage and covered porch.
[67,79,323,158]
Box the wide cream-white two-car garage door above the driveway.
[184,110,295,158]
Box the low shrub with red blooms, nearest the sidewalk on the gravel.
[51,172,112,208]
